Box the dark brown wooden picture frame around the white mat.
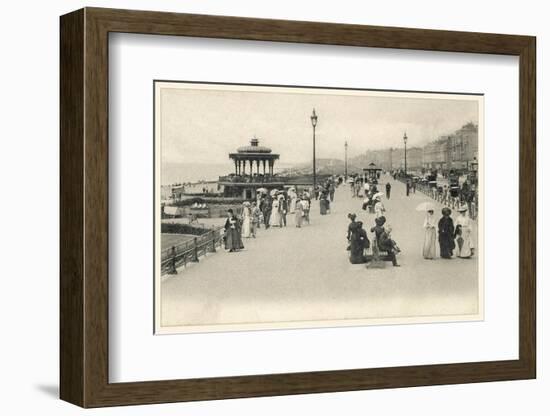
[60,8,536,407]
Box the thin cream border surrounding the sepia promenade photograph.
[153,79,485,335]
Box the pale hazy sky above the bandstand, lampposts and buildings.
[157,83,479,166]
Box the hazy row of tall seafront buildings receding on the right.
[361,123,478,172]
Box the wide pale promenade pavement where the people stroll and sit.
[161,176,478,327]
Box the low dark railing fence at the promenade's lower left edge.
[161,227,223,275]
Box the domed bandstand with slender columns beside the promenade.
[219,137,285,199]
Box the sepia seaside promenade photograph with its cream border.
[153,81,484,334]
